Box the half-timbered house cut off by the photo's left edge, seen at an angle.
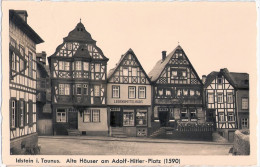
[9,10,43,154]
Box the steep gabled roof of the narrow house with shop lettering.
[107,48,151,83]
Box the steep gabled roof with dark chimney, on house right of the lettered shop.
[148,45,202,84]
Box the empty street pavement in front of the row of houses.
[39,136,232,155]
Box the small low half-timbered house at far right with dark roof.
[204,68,249,141]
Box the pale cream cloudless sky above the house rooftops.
[3,1,256,77]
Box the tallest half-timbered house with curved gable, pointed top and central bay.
[48,22,108,135]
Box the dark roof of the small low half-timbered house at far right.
[205,68,249,89]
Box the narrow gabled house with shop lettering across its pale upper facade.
[107,49,151,136]
